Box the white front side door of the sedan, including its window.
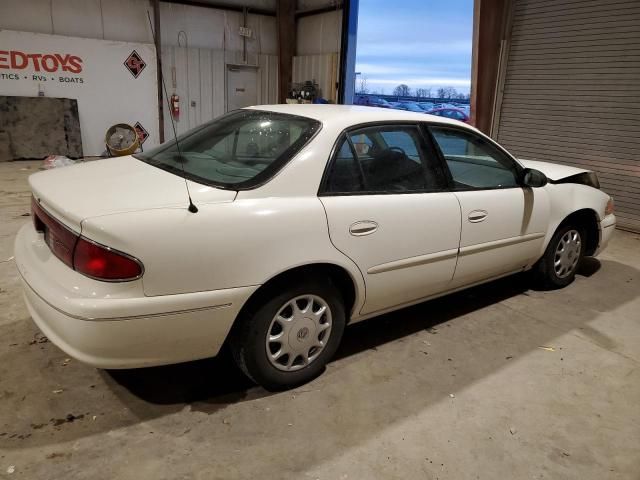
[429,126,549,288]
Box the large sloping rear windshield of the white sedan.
[134,110,320,190]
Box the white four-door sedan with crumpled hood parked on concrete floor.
[15,105,615,389]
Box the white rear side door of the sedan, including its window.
[320,124,460,314]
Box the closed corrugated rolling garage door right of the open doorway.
[494,0,640,232]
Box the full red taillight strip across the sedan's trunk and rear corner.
[31,198,144,282]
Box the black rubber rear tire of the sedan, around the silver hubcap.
[230,279,346,391]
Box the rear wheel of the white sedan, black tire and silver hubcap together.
[231,280,345,390]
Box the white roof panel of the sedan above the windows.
[247,103,475,130]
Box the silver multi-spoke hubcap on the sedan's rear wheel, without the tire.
[265,295,332,372]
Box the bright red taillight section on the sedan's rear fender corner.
[73,237,142,282]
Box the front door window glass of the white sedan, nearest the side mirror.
[430,127,519,190]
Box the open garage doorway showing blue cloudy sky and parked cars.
[354,0,474,121]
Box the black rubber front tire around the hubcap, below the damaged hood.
[534,224,586,289]
